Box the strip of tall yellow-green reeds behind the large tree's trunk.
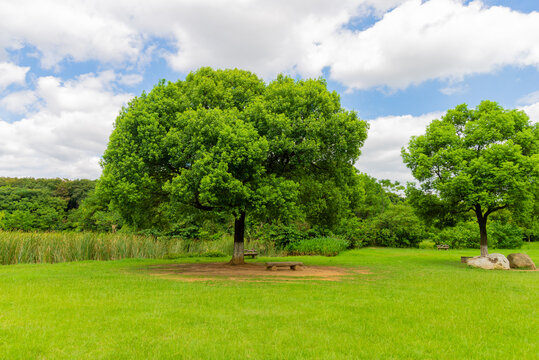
[0,231,284,265]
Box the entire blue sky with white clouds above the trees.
[0,0,539,181]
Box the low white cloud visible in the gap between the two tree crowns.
[356,112,443,184]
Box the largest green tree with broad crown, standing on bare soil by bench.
[97,68,367,264]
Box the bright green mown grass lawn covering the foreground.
[0,244,539,359]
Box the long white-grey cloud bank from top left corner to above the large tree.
[0,0,405,76]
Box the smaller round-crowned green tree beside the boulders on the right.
[402,101,539,255]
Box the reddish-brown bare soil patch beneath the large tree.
[145,263,370,281]
